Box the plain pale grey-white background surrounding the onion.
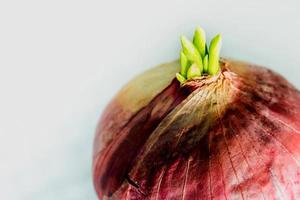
[0,0,300,200]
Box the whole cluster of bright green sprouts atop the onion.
[176,27,222,84]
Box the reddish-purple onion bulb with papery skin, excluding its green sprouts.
[93,60,300,200]
